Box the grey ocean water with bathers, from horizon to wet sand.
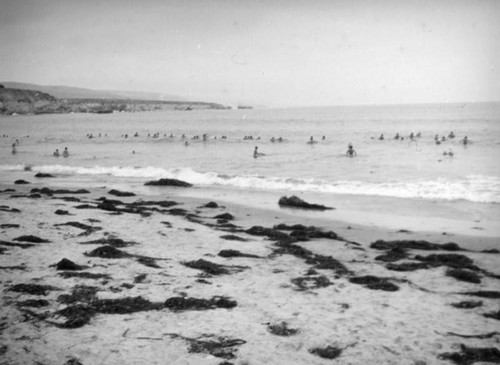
[0,103,500,234]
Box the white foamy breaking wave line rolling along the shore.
[0,165,500,203]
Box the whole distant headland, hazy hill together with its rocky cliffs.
[0,82,231,115]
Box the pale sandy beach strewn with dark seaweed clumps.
[0,180,500,365]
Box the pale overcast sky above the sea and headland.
[0,0,500,106]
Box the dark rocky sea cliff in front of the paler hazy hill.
[0,87,229,115]
